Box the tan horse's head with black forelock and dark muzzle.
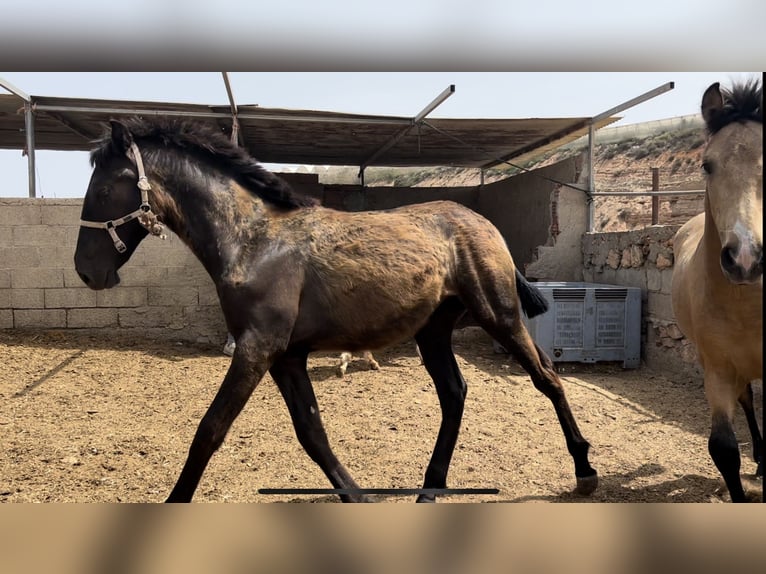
[702,83,763,283]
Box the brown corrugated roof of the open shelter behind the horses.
[0,94,619,167]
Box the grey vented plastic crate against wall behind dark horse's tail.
[495,281,641,369]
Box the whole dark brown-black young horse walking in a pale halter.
[74,118,598,502]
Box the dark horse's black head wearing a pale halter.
[74,121,156,290]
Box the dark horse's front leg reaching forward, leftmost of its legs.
[166,333,273,502]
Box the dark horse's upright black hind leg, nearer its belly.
[415,299,466,502]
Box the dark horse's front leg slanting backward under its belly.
[269,352,366,502]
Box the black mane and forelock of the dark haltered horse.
[90,117,317,209]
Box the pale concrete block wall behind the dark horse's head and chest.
[0,199,226,342]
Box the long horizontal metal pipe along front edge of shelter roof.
[34,104,412,126]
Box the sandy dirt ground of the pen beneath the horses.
[0,328,762,502]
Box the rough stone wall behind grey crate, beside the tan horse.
[582,225,701,379]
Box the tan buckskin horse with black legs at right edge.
[672,81,764,502]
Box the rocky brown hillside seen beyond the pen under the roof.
[319,128,704,231]
